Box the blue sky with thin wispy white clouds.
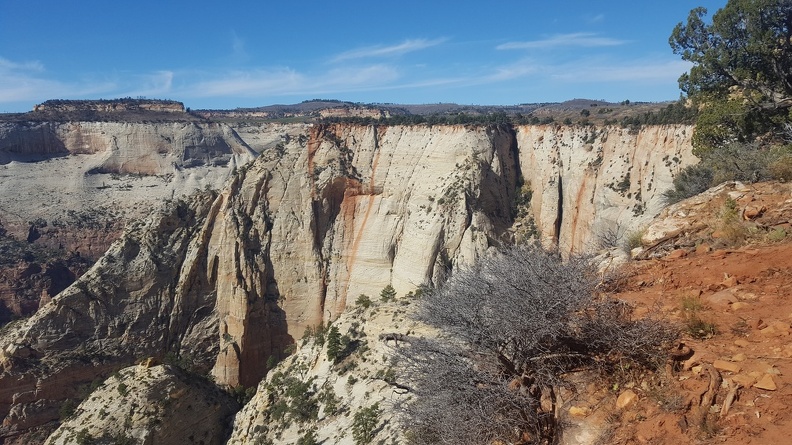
[0,0,726,112]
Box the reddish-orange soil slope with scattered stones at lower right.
[607,239,792,445]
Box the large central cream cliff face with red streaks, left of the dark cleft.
[209,122,517,386]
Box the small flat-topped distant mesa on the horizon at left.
[33,97,185,113]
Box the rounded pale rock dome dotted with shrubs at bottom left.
[45,365,239,445]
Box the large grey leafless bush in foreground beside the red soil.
[399,247,674,444]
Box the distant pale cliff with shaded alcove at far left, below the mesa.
[0,119,255,322]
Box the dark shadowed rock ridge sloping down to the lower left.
[0,193,217,438]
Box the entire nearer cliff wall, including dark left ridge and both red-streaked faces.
[0,124,692,437]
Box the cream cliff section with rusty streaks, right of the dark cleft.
[517,125,695,252]
